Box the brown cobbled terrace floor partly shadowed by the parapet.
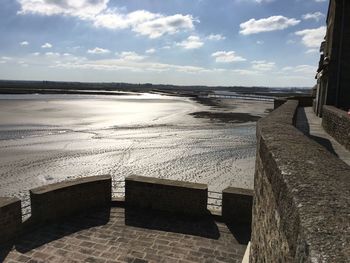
[0,207,249,263]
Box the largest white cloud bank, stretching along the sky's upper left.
[19,0,199,38]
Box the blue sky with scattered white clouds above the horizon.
[0,0,328,87]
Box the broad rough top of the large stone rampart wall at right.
[253,100,350,262]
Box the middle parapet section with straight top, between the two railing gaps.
[125,176,208,216]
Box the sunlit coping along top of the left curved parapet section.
[30,175,111,194]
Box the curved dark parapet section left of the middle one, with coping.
[30,175,112,222]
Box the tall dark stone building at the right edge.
[315,0,350,116]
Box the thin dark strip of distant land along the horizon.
[0,80,311,97]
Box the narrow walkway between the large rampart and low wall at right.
[296,107,350,165]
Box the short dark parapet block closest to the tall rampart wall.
[222,187,253,225]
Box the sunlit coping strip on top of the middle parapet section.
[125,175,208,190]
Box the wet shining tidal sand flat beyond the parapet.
[0,93,272,205]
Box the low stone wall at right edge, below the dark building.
[322,106,350,150]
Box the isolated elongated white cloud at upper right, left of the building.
[239,16,300,35]
